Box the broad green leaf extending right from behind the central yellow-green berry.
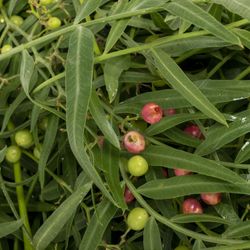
[142,146,246,183]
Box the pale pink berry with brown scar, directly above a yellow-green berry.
[123,131,145,154]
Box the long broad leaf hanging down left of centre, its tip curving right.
[65,27,114,203]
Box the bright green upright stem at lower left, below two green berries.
[13,162,34,250]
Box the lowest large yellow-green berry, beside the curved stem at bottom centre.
[127,207,149,231]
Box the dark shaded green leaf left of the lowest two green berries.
[101,141,127,211]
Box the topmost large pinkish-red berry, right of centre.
[141,102,163,124]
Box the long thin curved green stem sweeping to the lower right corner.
[120,166,246,245]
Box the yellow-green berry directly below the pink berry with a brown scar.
[128,155,148,176]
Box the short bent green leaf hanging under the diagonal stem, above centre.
[103,56,131,102]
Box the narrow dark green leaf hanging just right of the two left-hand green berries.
[38,115,59,188]
